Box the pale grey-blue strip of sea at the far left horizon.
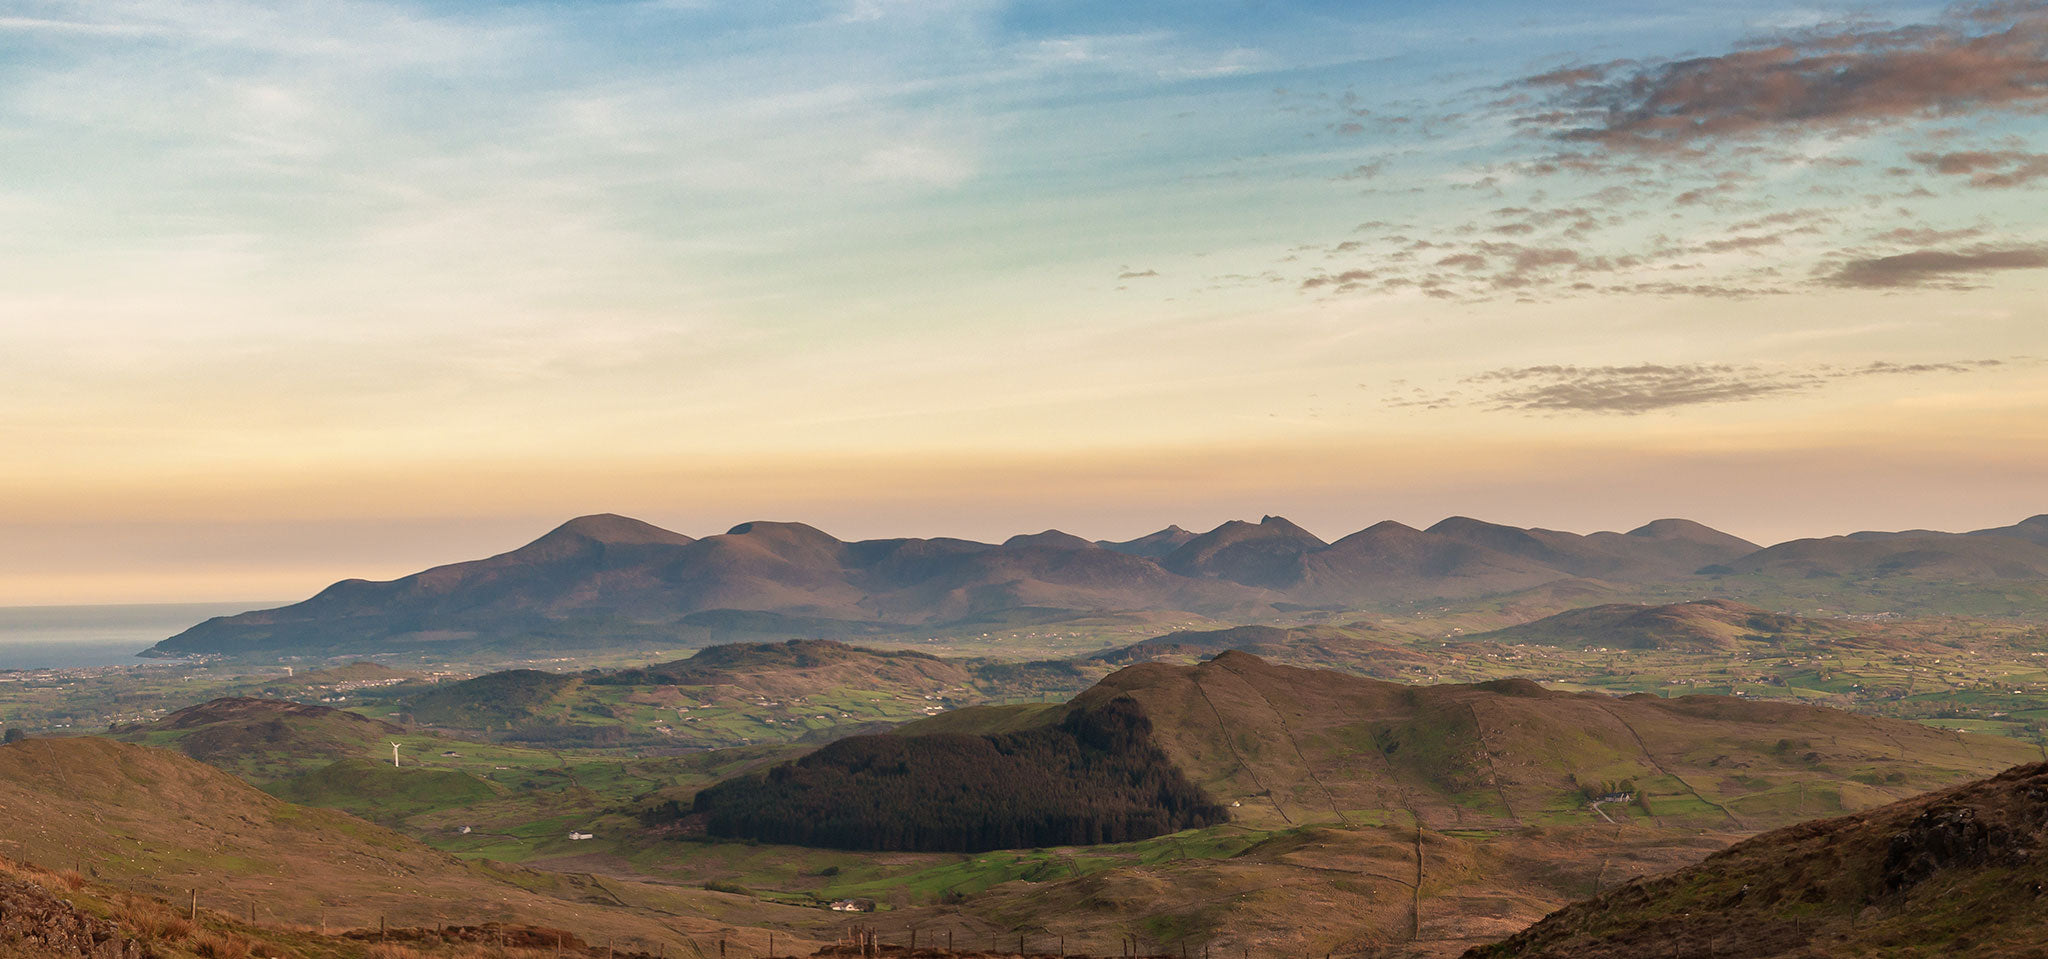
[0,602,279,670]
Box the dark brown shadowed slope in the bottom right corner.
[1466,764,2048,959]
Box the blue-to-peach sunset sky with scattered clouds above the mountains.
[0,0,2048,604]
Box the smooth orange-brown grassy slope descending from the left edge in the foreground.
[0,738,805,947]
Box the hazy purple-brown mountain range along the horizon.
[152,514,2048,656]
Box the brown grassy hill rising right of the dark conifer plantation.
[667,652,2036,848]
